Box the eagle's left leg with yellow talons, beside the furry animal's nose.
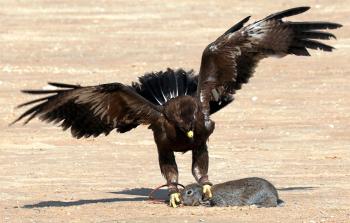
[158,148,180,207]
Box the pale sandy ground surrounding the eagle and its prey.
[0,0,350,223]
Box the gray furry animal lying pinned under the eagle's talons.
[181,177,283,207]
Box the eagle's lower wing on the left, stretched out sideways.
[13,83,161,138]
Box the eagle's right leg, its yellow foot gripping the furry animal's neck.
[192,145,213,198]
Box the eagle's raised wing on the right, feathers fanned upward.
[197,7,341,116]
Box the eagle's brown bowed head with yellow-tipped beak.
[164,95,204,139]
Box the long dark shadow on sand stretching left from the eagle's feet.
[22,188,168,208]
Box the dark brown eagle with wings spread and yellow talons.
[12,7,341,207]
